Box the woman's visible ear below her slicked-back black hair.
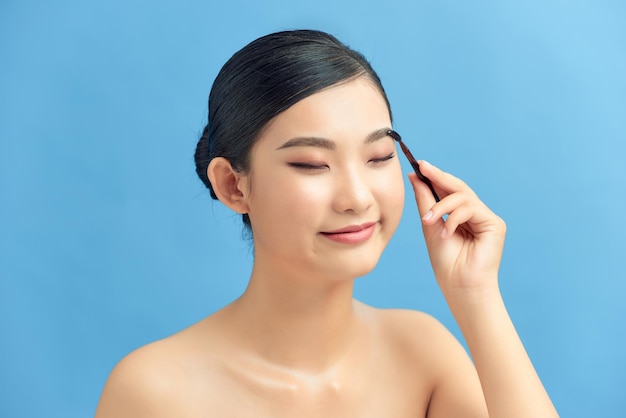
[207,157,248,214]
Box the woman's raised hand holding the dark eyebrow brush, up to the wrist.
[409,161,506,294]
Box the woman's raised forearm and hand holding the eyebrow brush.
[409,161,558,418]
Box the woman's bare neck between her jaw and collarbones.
[230,266,361,373]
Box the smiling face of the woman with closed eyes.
[241,77,404,279]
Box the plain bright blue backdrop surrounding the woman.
[0,0,626,417]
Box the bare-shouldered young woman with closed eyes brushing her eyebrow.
[96,31,557,418]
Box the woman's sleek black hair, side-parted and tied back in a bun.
[195,30,391,228]
